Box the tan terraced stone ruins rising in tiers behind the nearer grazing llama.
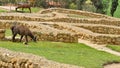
[0,8,120,44]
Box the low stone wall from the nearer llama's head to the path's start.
[34,32,78,43]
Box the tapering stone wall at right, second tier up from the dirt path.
[78,25,120,35]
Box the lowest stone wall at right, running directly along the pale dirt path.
[78,34,120,45]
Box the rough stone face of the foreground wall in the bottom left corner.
[0,53,40,68]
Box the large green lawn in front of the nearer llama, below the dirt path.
[0,41,120,68]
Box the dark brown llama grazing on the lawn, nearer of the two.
[11,25,36,44]
